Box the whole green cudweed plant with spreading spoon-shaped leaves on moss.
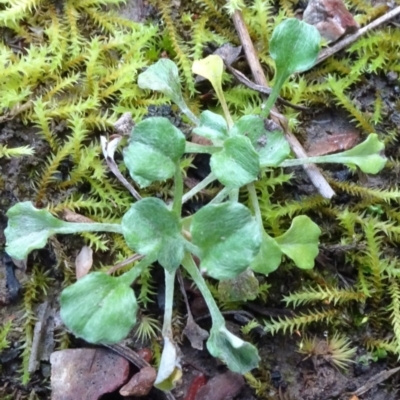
[5,19,386,390]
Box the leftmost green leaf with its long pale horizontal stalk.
[4,201,121,260]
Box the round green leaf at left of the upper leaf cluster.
[124,117,186,187]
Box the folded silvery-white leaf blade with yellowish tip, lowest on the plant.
[154,337,182,391]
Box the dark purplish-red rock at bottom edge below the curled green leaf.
[195,371,244,400]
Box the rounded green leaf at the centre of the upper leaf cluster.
[210,136,260,188]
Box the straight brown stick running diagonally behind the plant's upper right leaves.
[233,11,335,199]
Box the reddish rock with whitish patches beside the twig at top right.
[303,0,359,42]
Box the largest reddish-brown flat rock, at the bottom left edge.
[50,349,129,400]
